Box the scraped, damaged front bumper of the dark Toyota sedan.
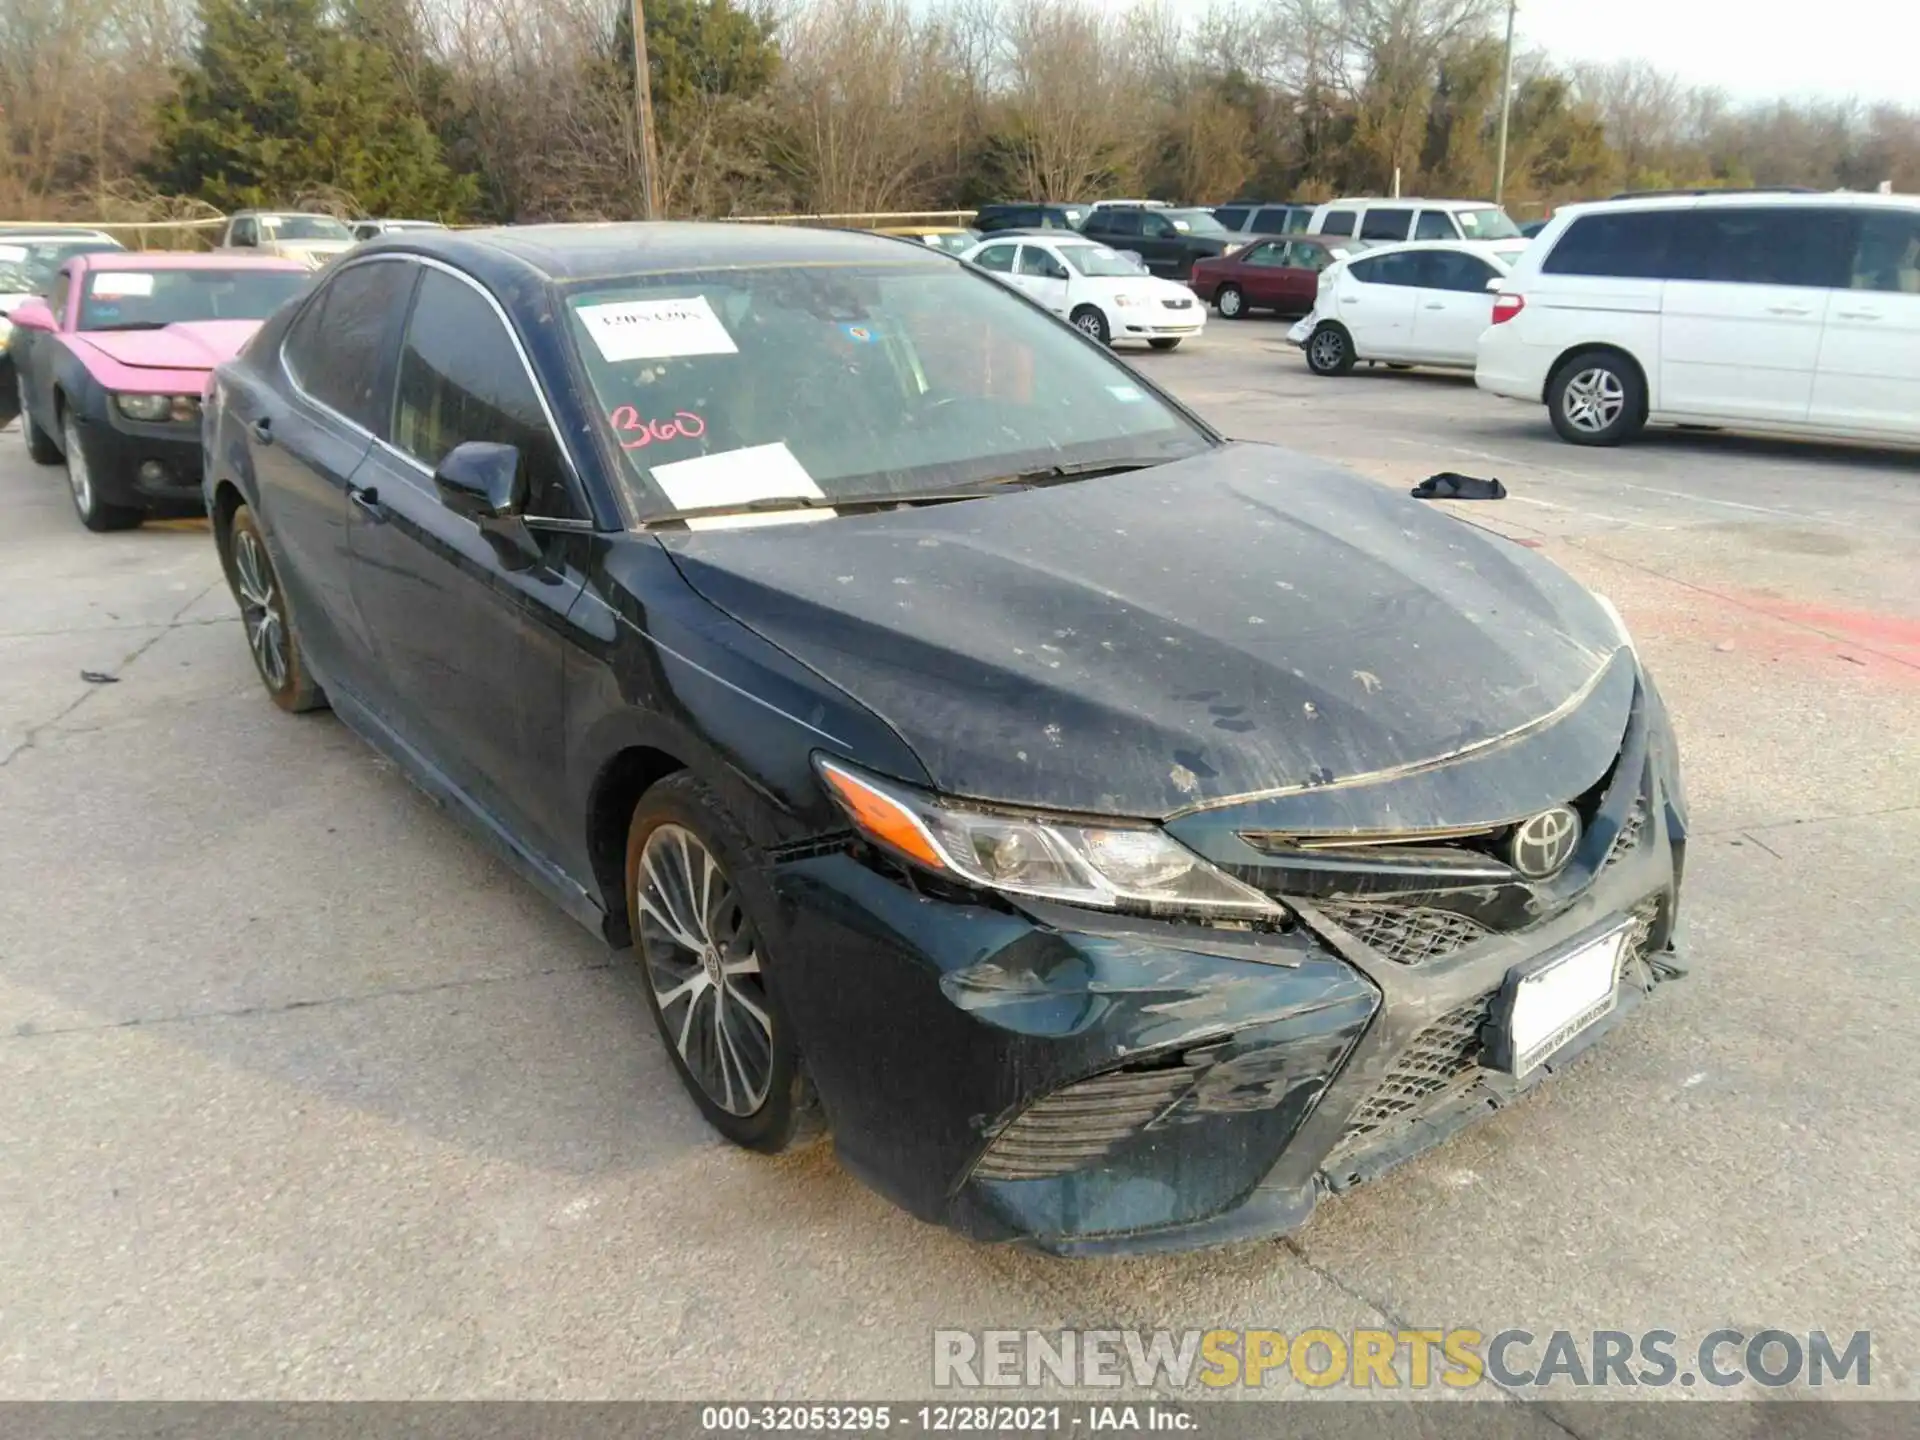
[760,664,1686,1256]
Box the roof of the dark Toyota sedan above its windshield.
[353,221,950,284]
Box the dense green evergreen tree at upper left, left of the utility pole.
[152,0,476,219]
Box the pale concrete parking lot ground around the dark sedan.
[0,321,1920,1432]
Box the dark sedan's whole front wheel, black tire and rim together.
[626,772,818,1154]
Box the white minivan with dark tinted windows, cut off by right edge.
[1475,192,1920,445]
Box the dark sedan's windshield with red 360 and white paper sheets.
[566,257,1212,520]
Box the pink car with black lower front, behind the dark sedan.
[8,253,313,530]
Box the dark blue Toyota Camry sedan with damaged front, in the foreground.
[204,225,1686,1254]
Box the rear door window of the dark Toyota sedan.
[280,261,413,434]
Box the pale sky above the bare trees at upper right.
[1515,0,1920,106]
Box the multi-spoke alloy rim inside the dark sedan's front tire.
[636,824,774,1116]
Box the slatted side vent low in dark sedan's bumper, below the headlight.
[973,1062,1204,1181]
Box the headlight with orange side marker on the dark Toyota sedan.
[814,756,1284,918]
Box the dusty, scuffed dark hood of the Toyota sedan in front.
[664,445,1626,816]
